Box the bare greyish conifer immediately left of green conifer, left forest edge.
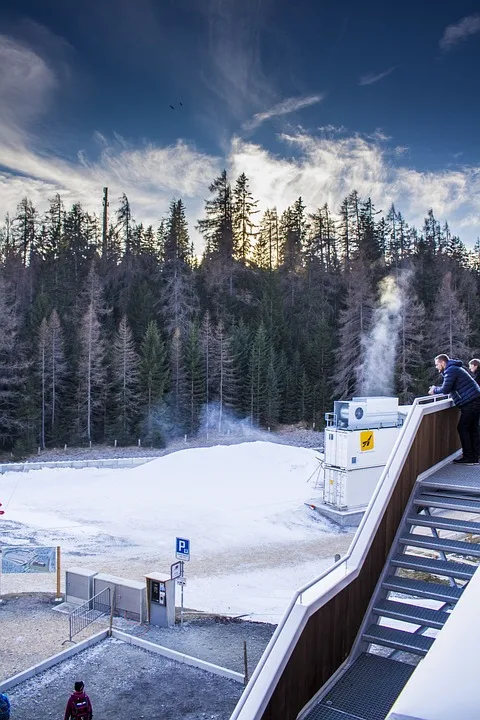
[112,315,139,443]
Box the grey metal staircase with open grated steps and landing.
[302,465,480,720]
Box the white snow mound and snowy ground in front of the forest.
[0,442,350,622]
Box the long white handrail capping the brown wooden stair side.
[230,395,449,720]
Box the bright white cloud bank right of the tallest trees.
[230,134,480,244]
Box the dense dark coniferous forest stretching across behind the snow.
[0,171,480,454]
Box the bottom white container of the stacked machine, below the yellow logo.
[323,466,383,510]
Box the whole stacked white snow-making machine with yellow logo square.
[323,397,406,524]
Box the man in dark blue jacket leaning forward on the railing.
[428,355,480,465]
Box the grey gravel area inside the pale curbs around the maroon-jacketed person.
[8,638,243,720]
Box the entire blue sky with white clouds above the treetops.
[0,0,480,246]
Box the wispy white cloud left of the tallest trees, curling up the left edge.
[0,35,221,232]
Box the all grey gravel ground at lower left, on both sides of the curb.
[0,593,275,720]
